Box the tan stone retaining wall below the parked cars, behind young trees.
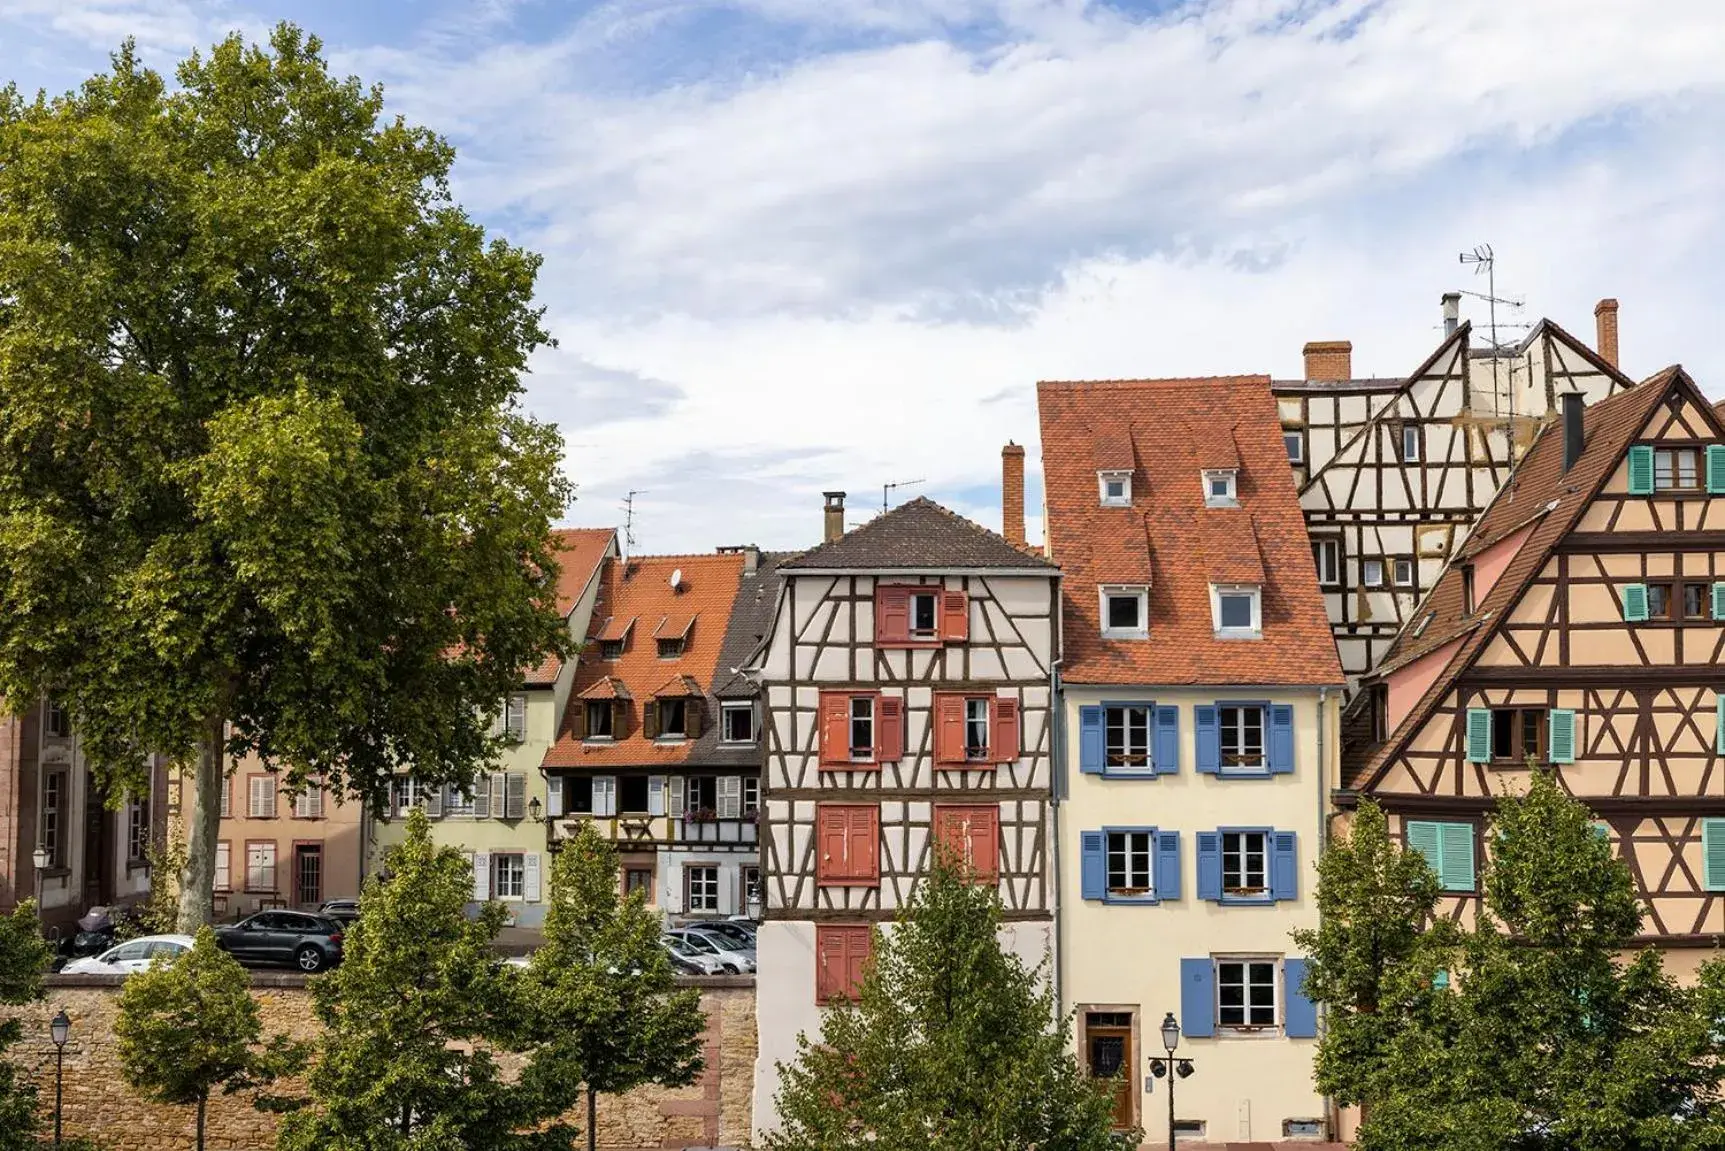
[0,972,756,1151]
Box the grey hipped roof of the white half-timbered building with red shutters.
[781,497,1056,575]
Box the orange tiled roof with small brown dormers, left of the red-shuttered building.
[545,552,743,768]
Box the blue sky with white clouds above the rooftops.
[0,0,1725,552]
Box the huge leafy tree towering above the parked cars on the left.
[0,24,569,930]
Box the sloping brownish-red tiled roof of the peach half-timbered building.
[1342,366,1683,790]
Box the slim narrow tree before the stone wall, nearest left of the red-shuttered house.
[521,825,707,1151]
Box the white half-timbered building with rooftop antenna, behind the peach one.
[1273,301,1632,683]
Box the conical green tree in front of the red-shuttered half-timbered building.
[766,859,1139,1151]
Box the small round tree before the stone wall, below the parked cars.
[114,927,304,1151]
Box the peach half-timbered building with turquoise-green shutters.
[1339,368,1725,970]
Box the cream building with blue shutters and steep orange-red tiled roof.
[1038,376,1342,1146]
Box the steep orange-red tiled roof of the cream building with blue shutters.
[1037,376,1342,685]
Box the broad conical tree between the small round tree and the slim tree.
[276,809,545,1151]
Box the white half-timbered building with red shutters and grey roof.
[754,492,1059,1130]
